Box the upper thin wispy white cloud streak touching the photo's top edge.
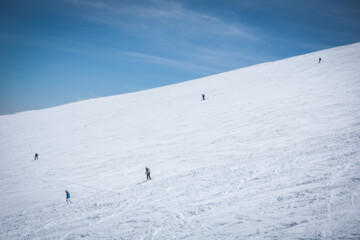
[67,0,260,41]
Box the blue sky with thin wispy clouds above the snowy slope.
[0,0,360,114]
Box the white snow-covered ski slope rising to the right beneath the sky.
[0,43,360,240]
